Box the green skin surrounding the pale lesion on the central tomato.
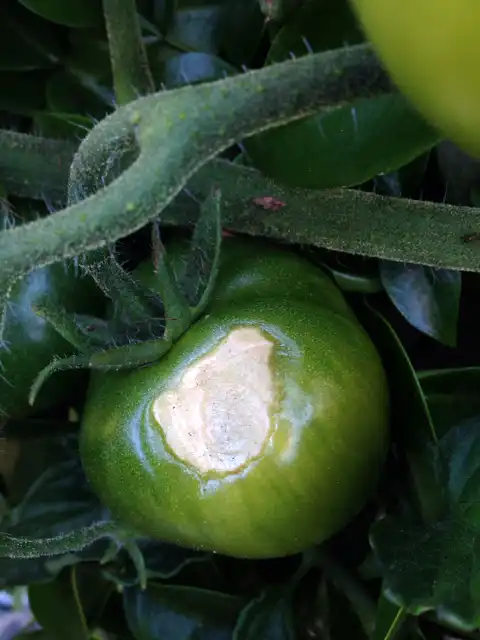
[80,243,388,558]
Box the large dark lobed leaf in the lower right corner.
[371,416,480,630]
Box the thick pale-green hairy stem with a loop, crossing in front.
[0,45,391,284]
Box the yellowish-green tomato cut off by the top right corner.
[352,0,480,157]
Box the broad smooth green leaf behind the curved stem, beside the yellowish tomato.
[244,0,439,189]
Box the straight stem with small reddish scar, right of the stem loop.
[0,141,480,271]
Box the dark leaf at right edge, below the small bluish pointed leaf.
[417,367,480,437]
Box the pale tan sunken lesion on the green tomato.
[153,327,275,473]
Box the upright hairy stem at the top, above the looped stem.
[103,0,155,105]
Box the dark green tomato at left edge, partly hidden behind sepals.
[0,263,102,418]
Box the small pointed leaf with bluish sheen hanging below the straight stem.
[380,260,462,347]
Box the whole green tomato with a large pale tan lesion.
[80,241,388,558]
